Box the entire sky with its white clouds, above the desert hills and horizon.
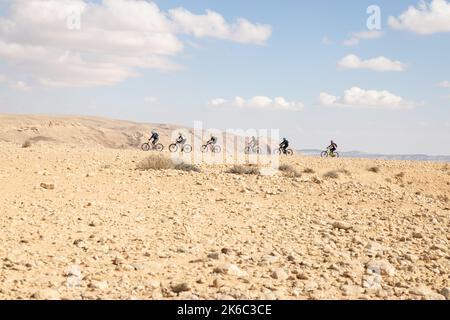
[0,0,450,155]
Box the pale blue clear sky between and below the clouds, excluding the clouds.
[0,0,450,155]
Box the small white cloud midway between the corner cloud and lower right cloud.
[338,54,406,71]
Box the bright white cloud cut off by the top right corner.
[388,0,450,35]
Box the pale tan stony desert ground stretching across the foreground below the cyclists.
[0,142,450,299]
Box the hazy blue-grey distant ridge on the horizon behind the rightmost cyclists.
[297,149,450,162]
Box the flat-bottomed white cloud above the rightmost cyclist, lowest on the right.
[318,87,416,109]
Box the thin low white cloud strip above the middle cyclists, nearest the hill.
[208,96,304,111]
